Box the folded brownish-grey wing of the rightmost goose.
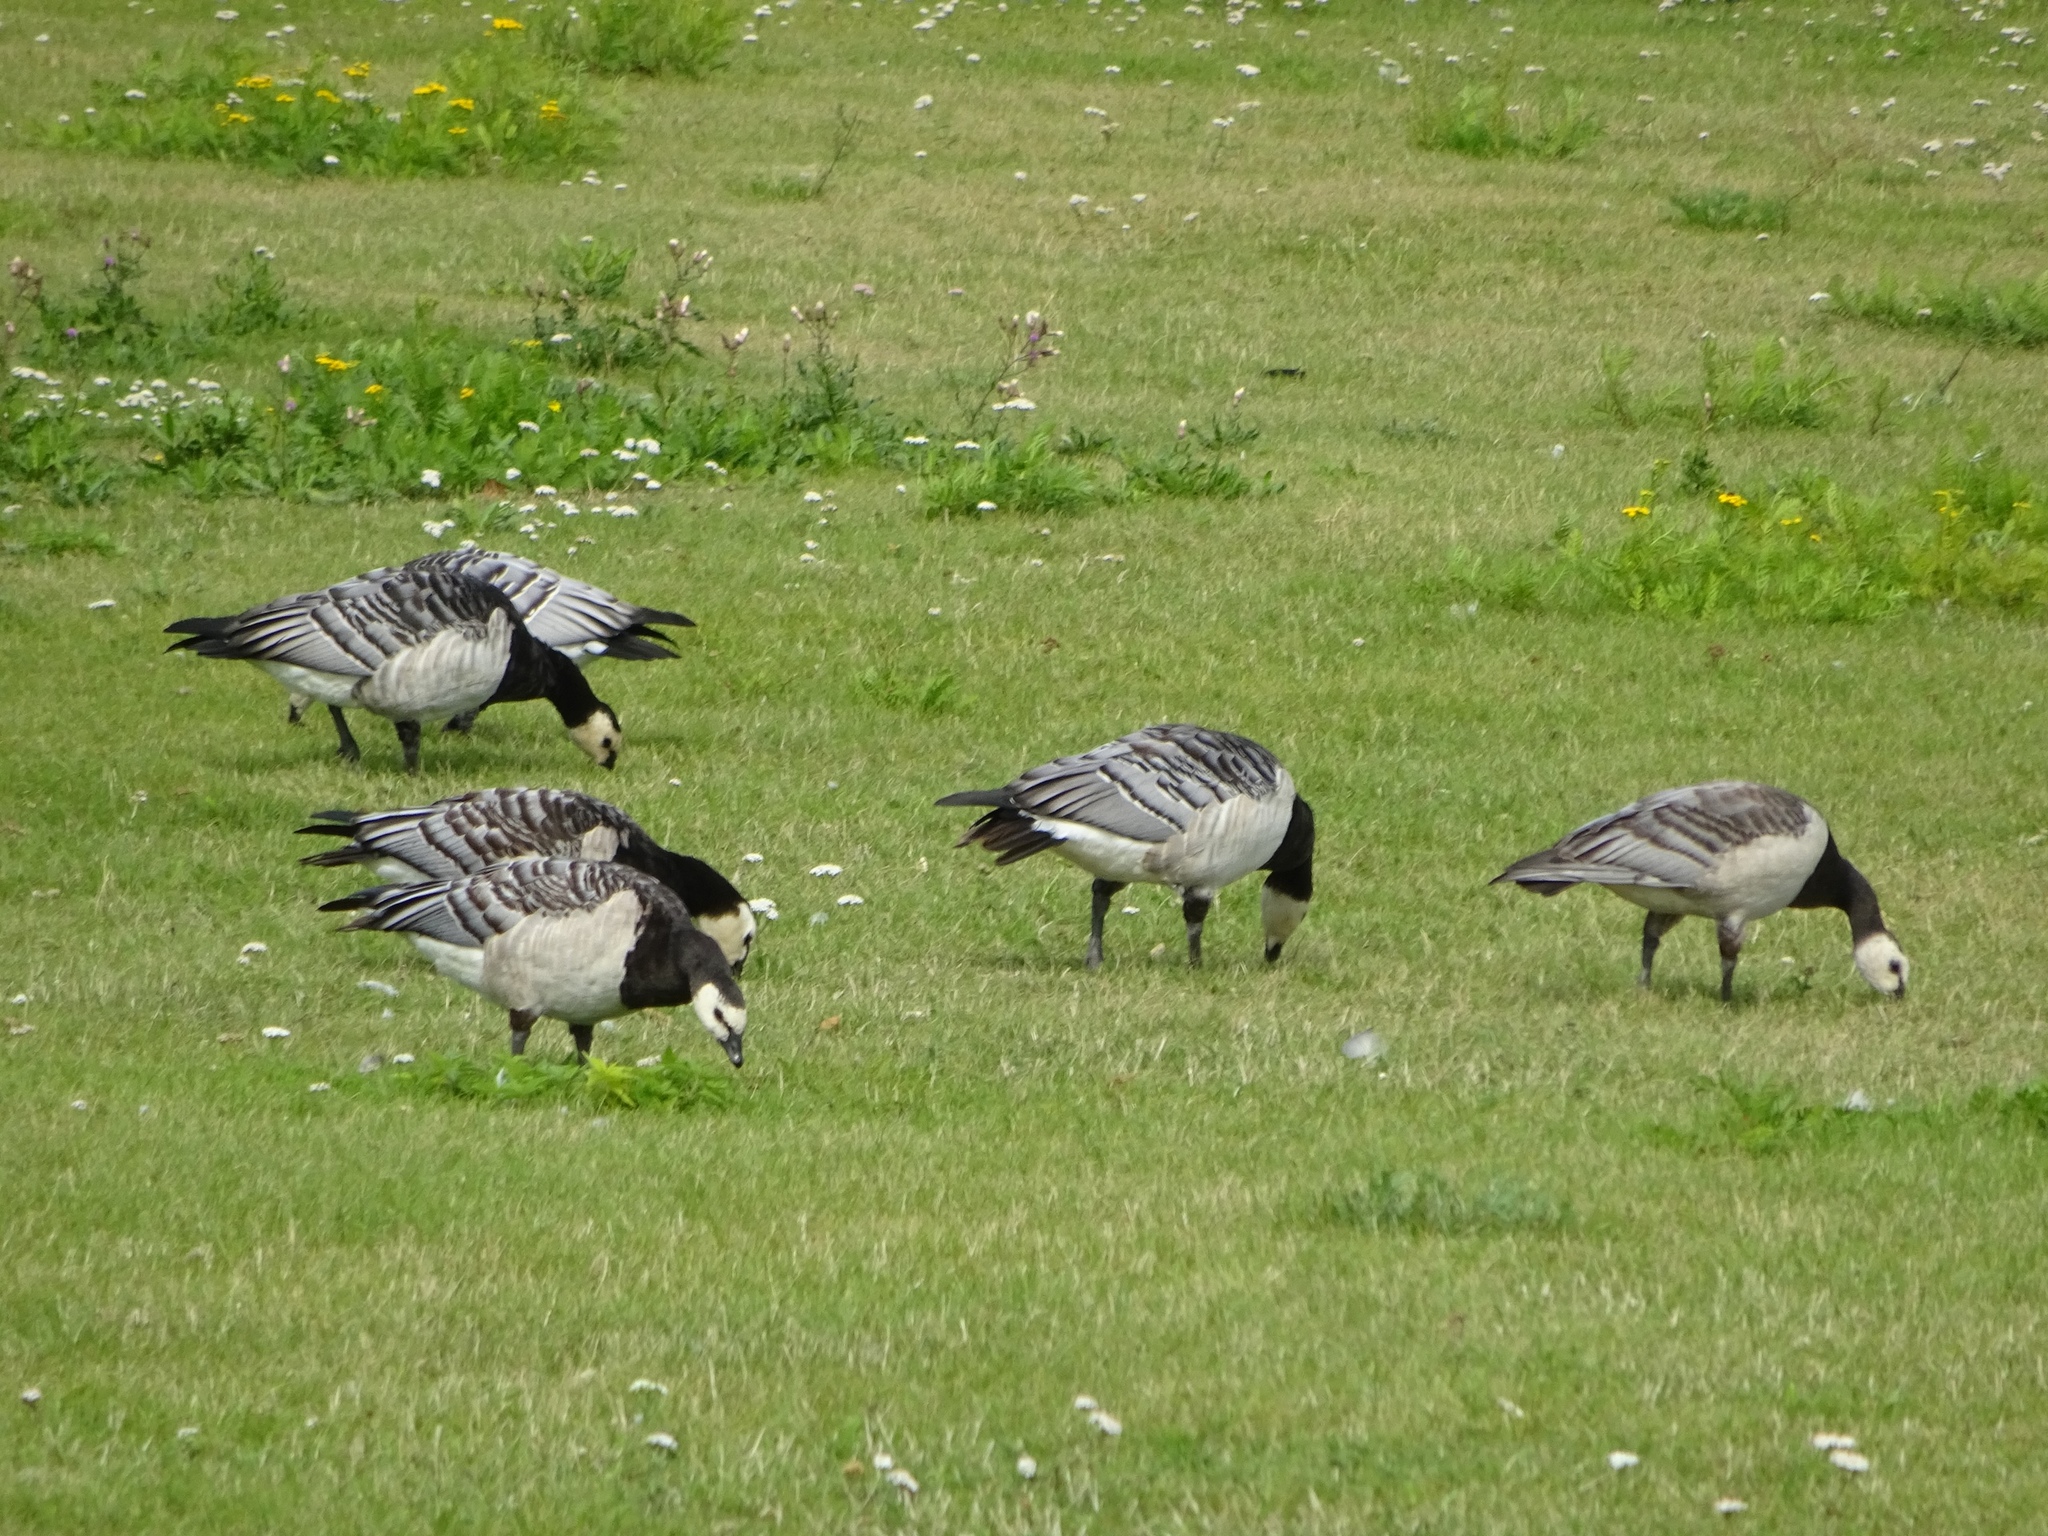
[1495,780,1815,891]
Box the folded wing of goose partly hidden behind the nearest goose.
[301,788,639,879]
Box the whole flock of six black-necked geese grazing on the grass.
[166,543,1909,1067]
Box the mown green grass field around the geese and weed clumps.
[0,0,2048,1532]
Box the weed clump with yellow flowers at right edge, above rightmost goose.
[1450,451,2048,623]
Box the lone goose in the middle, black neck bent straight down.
[940,725,1315,969]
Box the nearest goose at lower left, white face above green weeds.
[322,858,748,1067]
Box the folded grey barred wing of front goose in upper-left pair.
[166,571,508,678]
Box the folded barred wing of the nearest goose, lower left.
[319,858,655,948]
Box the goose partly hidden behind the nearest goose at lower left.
[299,788,754,975]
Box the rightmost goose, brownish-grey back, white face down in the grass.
[1493,778,1909,1001]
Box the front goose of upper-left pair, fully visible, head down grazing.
[164,569,625,772]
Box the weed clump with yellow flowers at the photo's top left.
[51,37,616,176]
